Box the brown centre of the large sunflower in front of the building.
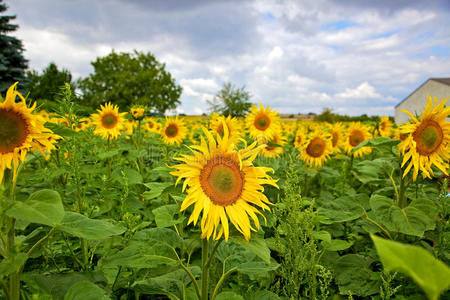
[413,120,444,155]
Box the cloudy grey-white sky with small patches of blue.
[4,0,450,115]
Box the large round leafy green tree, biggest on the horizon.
[78,50,182,113]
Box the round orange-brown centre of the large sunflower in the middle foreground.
[200,156,244,206]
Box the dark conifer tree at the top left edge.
[0,0,28,95]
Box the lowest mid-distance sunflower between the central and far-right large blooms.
[299,130,333,168]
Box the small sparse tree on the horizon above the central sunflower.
[208,82,252,117]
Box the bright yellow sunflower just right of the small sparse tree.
[245,103,280,140]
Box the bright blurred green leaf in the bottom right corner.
[371,235,450,300]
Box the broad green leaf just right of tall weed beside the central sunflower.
[318,194,368,224]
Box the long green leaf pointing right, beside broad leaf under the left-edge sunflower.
[57,211,125,240]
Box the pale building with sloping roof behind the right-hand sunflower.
[395,78,450,124]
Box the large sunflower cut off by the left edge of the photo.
[0,82,60,183]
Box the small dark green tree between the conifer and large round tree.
[26,62,72,102]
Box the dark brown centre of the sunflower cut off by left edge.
[0,109,28,154]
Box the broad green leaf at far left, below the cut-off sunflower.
[6,190,64,227]
